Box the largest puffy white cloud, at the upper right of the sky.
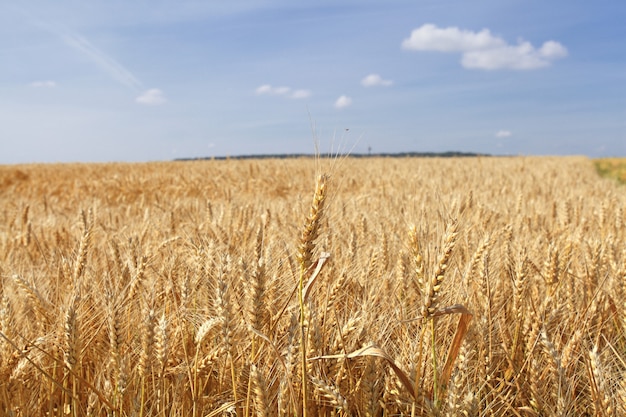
[402,24,567,70]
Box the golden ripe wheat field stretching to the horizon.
[0,157,626,417]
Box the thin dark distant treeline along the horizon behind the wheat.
[175,151,491,161]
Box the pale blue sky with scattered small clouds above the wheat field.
[0,0,626,164]
